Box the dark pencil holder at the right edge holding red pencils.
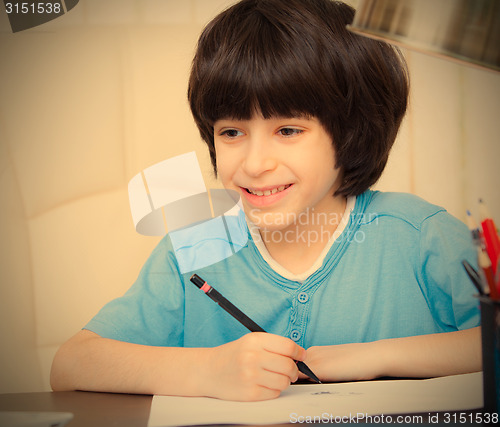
[479,297,500,413]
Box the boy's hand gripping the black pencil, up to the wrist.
[200,332,306,401]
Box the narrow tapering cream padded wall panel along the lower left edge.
[0,138,42,393]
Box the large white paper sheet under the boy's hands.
[148,372,483,427]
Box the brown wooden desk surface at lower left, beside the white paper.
[0,391,480,427]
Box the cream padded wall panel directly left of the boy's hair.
[124,26,203,179]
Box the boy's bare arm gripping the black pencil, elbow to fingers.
[51,330,305,400]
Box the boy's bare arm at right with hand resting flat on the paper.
[305,327,482,381]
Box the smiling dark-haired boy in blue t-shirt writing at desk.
[51,0,481,400]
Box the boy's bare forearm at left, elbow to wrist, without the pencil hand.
[51,331,205,396]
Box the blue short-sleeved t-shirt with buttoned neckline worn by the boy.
[85,191,479,348]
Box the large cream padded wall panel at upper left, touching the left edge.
[0,31,125,217]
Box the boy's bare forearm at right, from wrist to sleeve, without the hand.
[372,327,482,377]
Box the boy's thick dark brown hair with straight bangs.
[188,0,409,196]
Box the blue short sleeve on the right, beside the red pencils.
[420,211,480,331]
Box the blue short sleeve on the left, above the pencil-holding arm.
[84,236,184,347]
